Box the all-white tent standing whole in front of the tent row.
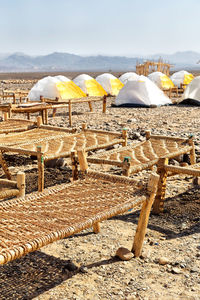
[115,76,172,107]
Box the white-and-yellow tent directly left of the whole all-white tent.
[96,73,124,96]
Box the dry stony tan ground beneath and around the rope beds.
[0,75,200,300]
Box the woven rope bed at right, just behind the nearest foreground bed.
[87,132,195,175]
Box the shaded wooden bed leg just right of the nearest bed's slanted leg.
[153,158,168,214]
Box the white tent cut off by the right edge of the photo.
[180,76,200,105]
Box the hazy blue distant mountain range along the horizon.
[0,51,200,72]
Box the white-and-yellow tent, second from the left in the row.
[73,74,107,96]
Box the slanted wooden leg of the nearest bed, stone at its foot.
[131,174,159,257]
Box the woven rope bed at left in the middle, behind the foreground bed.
[0,125,126,191]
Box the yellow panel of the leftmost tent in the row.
[56,81,86,99]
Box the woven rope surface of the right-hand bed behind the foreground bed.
[90,138,188,166]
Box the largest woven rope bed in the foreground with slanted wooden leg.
[0,171,159,264]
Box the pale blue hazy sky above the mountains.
[0,0,200,56]
